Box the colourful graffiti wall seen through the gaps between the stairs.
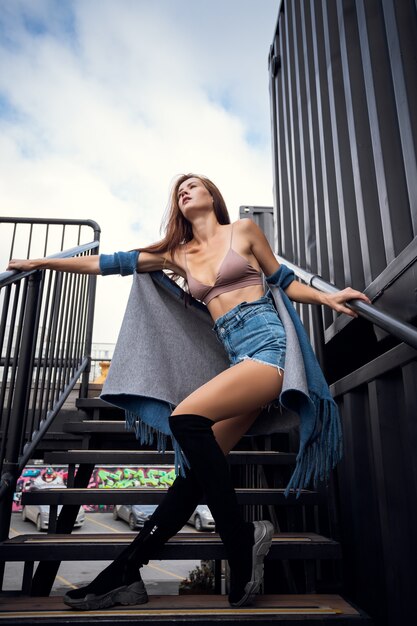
[13,465,175,511]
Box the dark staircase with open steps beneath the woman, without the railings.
[0,390,370,624]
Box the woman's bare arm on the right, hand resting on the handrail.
[242,220,371,317]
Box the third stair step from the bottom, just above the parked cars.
[22,487,318,506]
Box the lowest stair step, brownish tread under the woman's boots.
[0,594,370,626]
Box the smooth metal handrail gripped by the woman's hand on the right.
[275,255,417,350]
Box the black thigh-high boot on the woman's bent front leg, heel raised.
[169,415,273,606]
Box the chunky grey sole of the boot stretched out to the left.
[63,581,148,611]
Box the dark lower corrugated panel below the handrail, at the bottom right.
[332,344,417,626]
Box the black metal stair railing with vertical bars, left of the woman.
[0,218,100,540]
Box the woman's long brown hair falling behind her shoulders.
[139,174,230,252]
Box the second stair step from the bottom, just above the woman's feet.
[0,533,341,561]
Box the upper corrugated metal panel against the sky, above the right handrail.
[270,0,417,338]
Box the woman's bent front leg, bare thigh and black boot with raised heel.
[170,360,282,606]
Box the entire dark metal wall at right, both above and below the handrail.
[269,0,417,626]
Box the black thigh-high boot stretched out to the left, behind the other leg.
[64,470,202,611]
